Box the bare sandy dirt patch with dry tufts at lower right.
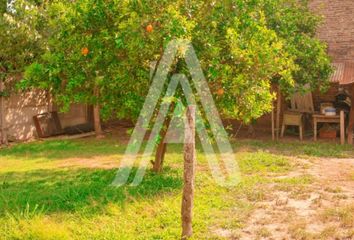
[238,159,354,240]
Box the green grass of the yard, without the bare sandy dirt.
[0,139,349,240]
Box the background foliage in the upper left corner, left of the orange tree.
[0,0,43,91]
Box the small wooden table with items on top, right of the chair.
[313,111,345,144]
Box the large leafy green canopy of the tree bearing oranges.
[22,0,331,134]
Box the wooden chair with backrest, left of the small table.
[281,93,315,141]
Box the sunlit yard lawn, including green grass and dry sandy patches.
[0,137,354,240]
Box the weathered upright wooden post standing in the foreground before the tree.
[181,106,196,239]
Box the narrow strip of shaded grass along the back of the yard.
[0,138,354,160]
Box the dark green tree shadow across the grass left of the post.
[0,168,182,216]
